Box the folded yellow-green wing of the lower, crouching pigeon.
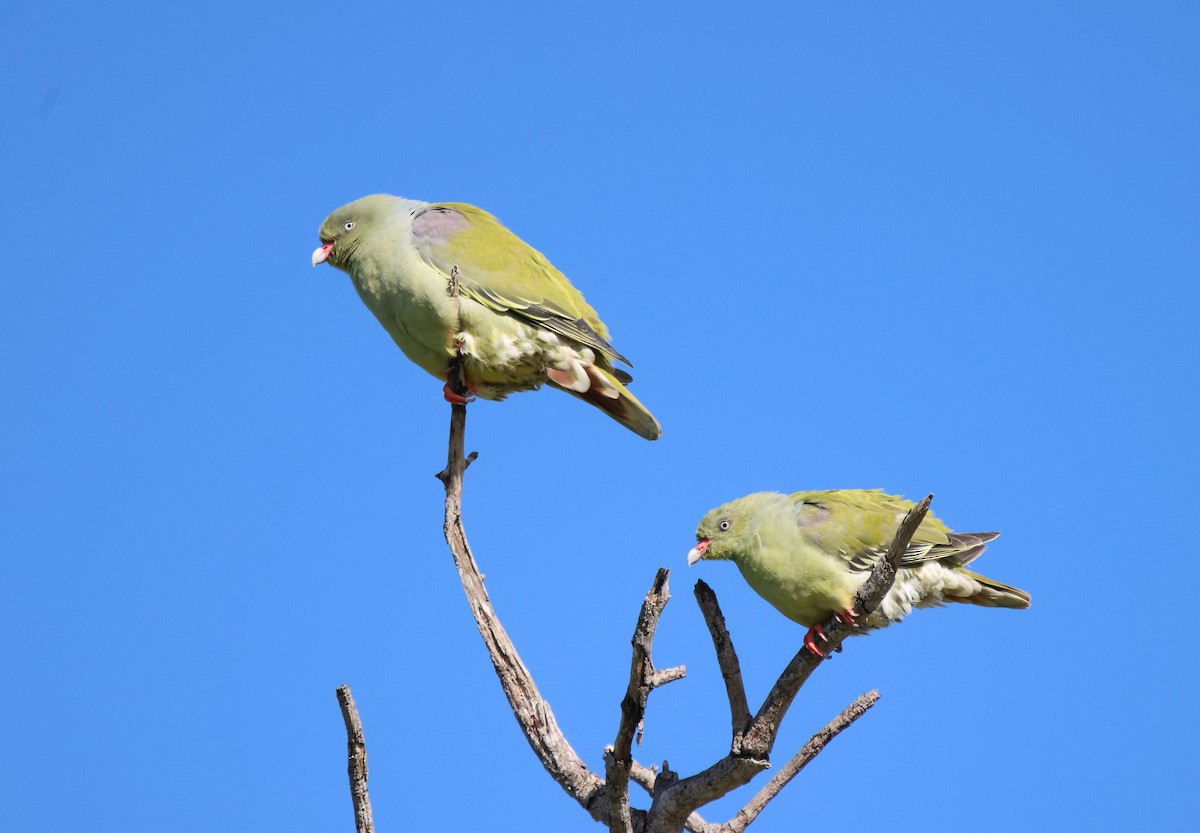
[791,489,1000,571]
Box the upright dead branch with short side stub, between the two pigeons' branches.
[605,568,684,833]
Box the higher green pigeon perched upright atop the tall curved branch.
[312,194,662,439]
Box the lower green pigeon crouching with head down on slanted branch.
[688,489,1030,657]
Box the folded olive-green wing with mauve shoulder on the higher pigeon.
[413,203,632,366]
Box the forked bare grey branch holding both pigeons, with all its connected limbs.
[438,343,932,833]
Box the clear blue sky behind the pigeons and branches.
[0,0,1200,833]
